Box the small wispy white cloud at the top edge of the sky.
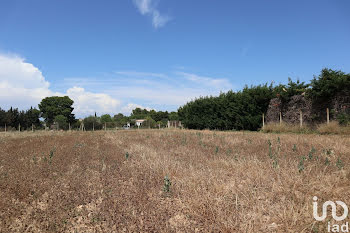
[133,0,171,28]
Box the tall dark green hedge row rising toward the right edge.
[178,69,350,130]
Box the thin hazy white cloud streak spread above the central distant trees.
[65,71,233,109]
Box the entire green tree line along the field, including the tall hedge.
[0,68,350,130]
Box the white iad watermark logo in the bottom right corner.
[313,196,349,232]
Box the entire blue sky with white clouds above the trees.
[0,0,350,117]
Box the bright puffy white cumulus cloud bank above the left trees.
[0,54,120,117]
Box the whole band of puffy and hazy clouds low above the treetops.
[0,54,233,117]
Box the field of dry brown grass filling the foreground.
[0,130,350,232]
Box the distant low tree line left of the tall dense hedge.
[0,96,178,131]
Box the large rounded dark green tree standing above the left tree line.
[39,96,75,124]
